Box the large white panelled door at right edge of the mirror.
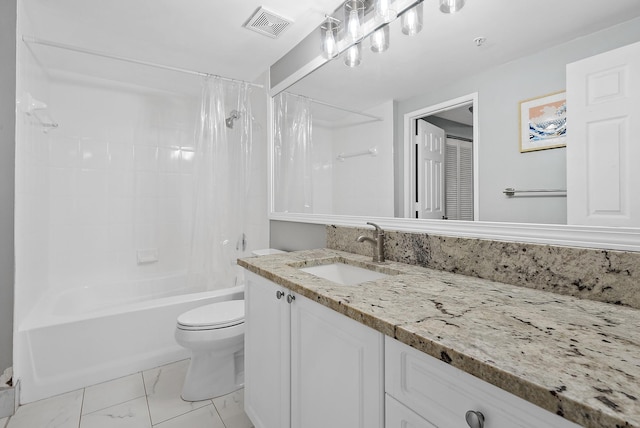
[567,43,640,227]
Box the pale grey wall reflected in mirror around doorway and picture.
[394,19,640,223]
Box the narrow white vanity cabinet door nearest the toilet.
[244,272,290,428]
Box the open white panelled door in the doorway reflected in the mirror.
[414,120,445,219]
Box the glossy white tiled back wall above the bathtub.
[48,74,199,290]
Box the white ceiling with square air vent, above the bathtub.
[22,0,341,81]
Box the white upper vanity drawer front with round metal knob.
[385,337,579,428]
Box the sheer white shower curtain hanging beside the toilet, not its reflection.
[188,77,253,290]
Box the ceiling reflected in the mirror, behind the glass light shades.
[287,0,640,110]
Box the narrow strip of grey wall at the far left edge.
[0,0,17,373]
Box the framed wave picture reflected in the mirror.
[520,91,567,153]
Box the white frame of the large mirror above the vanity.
[267,31,640,252]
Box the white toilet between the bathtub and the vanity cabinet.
[175,249,283,401]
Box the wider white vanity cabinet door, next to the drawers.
[291,296,384,428]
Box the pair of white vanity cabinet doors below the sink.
[245,272,384,428]
